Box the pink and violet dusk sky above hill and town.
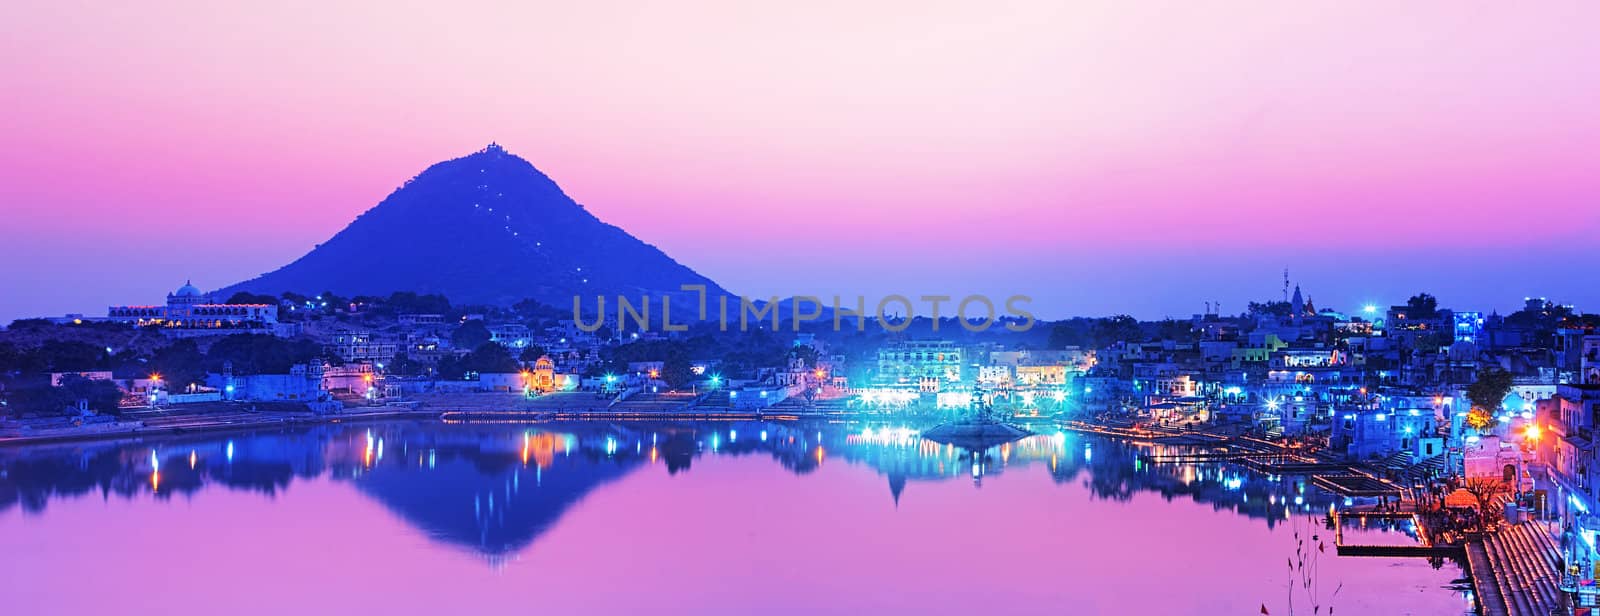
[0,2,1600,318]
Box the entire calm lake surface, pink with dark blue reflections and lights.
[0,422,1472,614]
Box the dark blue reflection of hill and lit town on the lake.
[0,422,1341,558]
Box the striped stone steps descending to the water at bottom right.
[1467,522,1568,616]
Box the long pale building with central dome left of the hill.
[107,280,278,338]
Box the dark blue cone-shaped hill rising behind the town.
[216,144,726,309]
